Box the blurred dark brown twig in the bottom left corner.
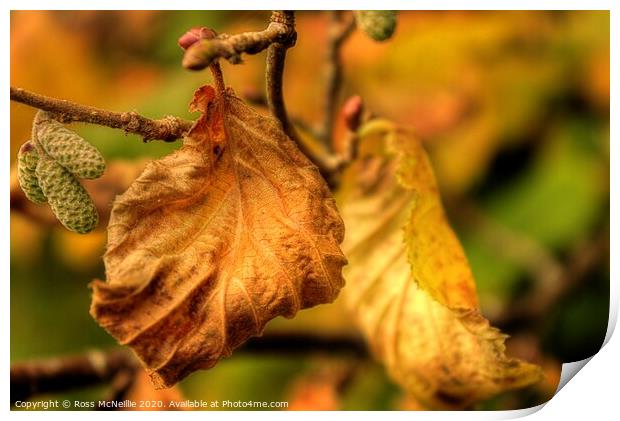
[11,349,137,404]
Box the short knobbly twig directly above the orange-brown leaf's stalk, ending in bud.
[183,11,296,70]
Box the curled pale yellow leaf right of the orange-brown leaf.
[337,120,541,408]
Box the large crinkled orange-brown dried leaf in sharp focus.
[91,86,346,387]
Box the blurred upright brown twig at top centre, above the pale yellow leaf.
[319,10,355,148]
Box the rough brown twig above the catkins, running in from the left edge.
[11,86,192,142]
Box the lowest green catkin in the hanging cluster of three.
[36,157,99,234]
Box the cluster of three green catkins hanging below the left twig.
[17,111,105,234]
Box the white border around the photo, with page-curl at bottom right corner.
[0,0,620,421]
